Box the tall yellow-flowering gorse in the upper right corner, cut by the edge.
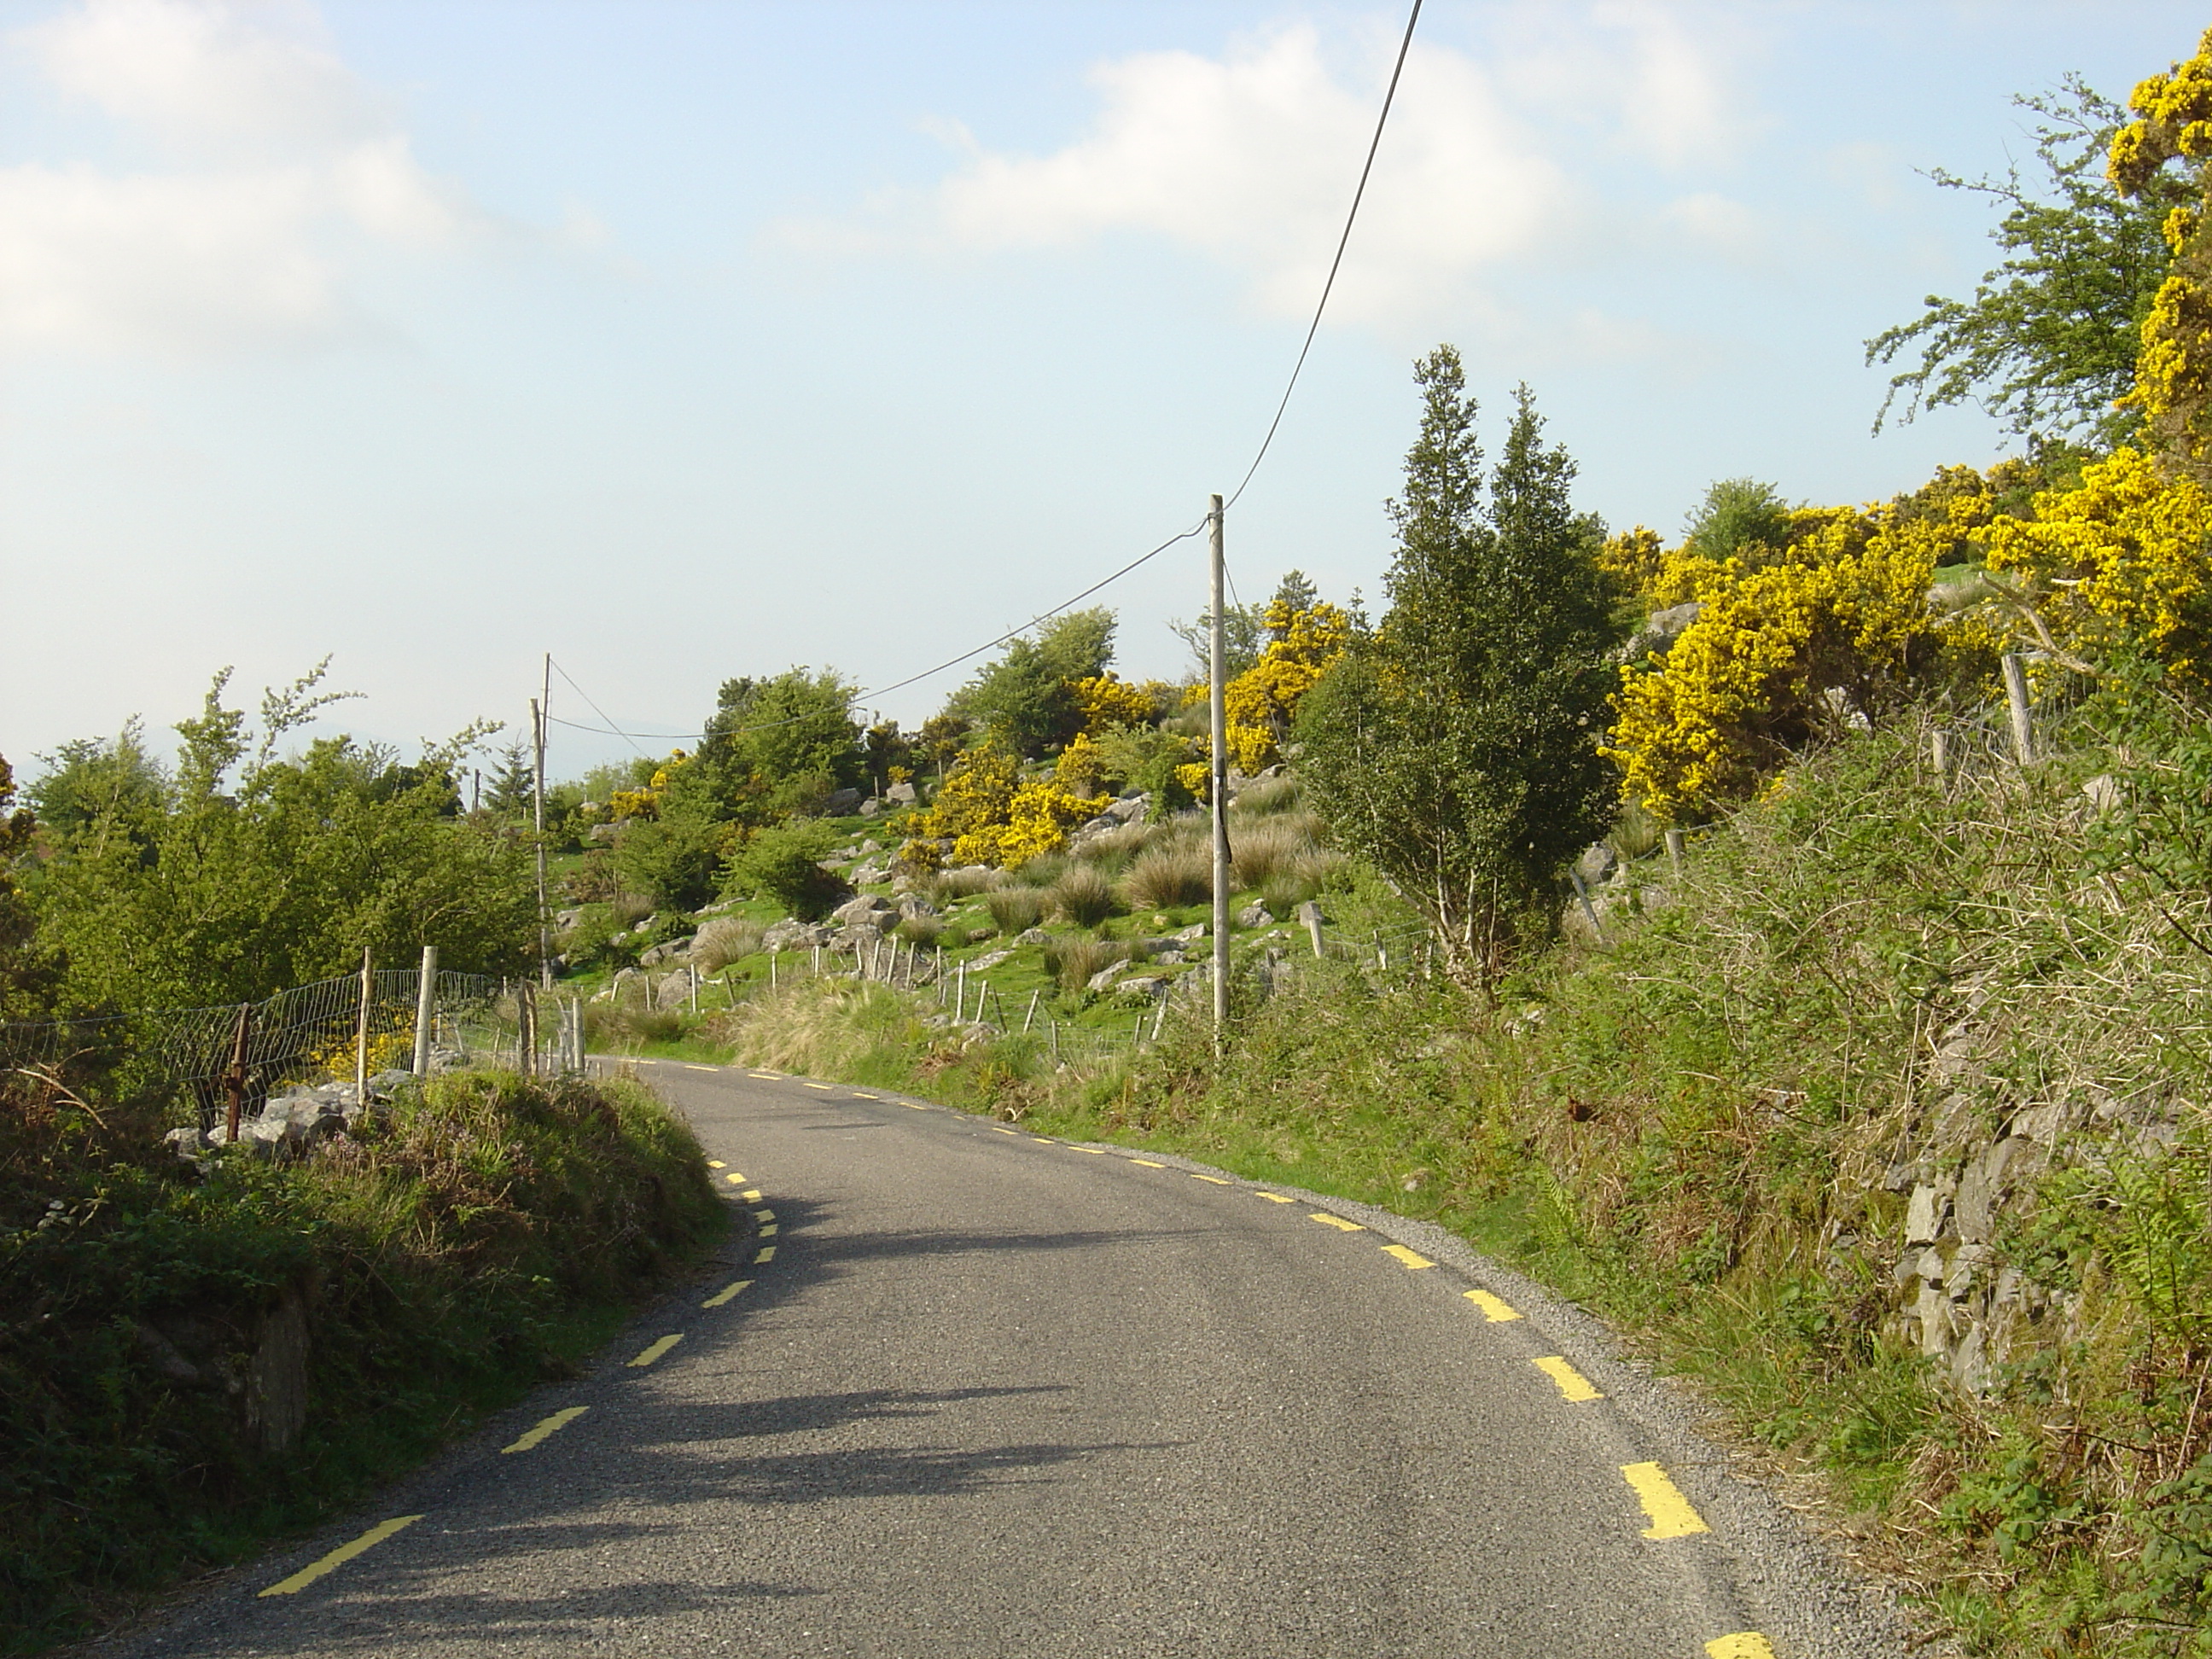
[2108,29,2212,485]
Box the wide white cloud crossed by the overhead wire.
[774,0,1743,328]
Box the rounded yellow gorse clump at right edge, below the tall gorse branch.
[1984,449,2212,686]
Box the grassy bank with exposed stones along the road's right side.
[716,710,2212,1655]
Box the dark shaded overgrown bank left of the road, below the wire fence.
[0,1073,725,1652]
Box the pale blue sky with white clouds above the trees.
[0,0,2205,774]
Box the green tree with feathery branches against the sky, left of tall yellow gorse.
[1867,75,2197,449]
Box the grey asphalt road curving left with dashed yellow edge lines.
[111,1062,1902,1659]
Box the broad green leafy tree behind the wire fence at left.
[31,668,538,1011]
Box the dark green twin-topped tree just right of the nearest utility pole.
[1299,345,1619,987]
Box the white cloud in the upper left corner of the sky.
[0,0,480,352]
